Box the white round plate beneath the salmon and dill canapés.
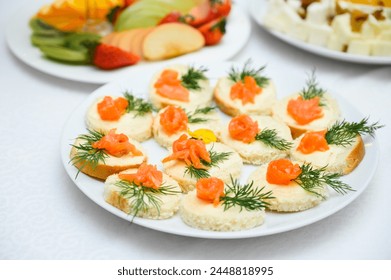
[61,62,379,239]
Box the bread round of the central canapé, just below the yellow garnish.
[163,143,243,193]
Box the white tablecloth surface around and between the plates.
[0,0,391,260]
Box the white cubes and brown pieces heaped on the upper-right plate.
[263,0,391,56]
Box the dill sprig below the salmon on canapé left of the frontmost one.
[115,180,181,218]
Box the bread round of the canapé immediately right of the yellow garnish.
[221,116,292,165]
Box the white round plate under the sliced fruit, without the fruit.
[6,0,251,84]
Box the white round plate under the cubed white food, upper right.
[249,0,391,65]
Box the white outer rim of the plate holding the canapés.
[60,61,379,239]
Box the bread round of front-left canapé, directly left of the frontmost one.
[103,168,182,220]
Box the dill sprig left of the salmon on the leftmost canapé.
[70,130,108,178]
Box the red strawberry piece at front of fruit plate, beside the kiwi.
[92,44,140,70]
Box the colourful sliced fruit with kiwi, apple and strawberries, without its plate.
[30,0,231,70]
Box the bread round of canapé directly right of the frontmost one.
[248,164,328,212]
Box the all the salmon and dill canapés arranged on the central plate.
[70,62,381,231]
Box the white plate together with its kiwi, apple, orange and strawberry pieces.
[6,0,250,84]
